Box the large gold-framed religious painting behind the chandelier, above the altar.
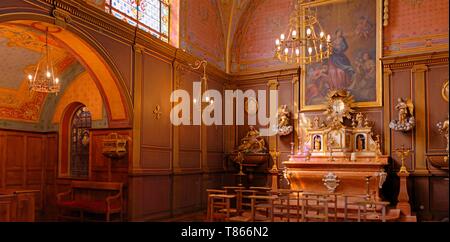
[301,0,381,111]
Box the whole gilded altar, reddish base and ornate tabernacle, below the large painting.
[283,90,388,196]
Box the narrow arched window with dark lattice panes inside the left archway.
[69,106,92,178]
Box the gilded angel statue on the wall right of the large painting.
[389,98,416,132]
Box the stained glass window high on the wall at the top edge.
[106,0,170,42]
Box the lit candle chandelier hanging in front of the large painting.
[275,0,332,65]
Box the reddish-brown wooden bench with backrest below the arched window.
[57,181,123,222]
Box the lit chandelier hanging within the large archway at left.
[28,27,61,93]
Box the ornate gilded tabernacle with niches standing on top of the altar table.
[304,90,381,159]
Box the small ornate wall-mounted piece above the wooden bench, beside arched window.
[102,133,130,159]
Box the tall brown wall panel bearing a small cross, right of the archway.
[140,52,173,173]
